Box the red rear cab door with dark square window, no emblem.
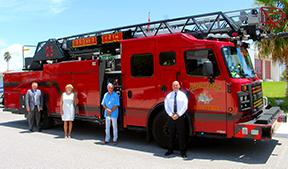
[121,39,156,128]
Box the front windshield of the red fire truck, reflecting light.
[222,46,256,78]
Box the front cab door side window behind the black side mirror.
[184,49,220,77]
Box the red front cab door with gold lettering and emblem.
[180,45,227,135]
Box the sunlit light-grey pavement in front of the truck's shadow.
[0,108,288,169]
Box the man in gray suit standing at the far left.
[25,82,43,132]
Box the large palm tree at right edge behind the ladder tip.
[255,0,288,96]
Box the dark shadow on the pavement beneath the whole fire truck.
[0,117,282,164]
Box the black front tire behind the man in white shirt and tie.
[152,110,192,149]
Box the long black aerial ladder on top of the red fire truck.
[25,7,288,70]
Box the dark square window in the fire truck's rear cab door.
[131,53,154,77]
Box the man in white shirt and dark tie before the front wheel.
[164,81,188,158]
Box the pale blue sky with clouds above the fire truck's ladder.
[0,0,254,72]
